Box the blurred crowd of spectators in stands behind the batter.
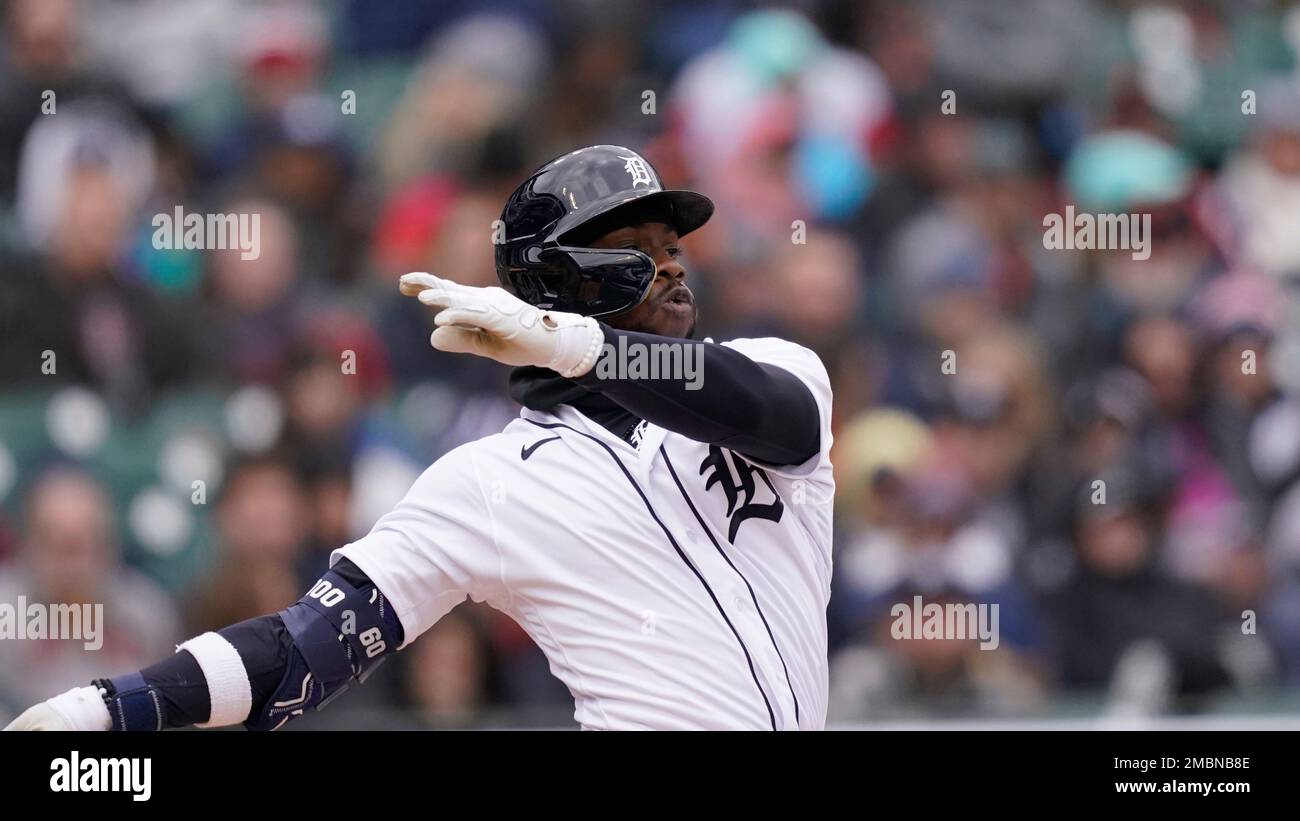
[0,0,1300,726]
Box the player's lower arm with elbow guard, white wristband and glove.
[5,559,403,730]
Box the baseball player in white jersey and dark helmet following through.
[9,145,835,730]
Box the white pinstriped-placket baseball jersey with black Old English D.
[332,338,835,730]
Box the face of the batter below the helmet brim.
[592,222,698,339]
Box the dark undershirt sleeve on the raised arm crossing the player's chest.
[576,323,822,466]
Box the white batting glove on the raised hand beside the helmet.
[400,272,605,379]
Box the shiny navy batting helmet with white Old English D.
[497,145,714,317]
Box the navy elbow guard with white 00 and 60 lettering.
[244,570,403,730]
